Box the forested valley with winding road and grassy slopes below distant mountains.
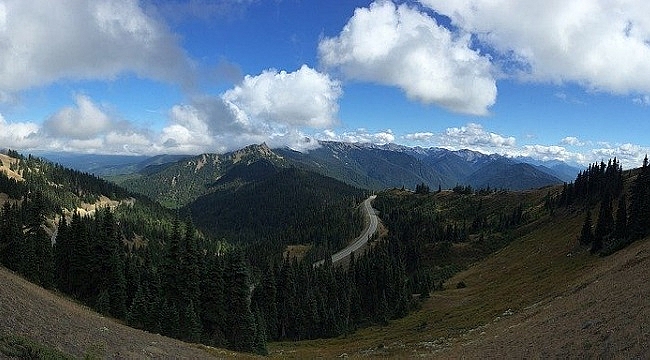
[0,144,650,358]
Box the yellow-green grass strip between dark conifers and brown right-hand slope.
[269,190,599,358]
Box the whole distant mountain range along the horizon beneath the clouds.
[42,141,580,207]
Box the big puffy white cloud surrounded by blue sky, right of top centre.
[318,1,497,115]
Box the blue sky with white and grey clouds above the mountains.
[0,0,650,168]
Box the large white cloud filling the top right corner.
[420,0,650,94]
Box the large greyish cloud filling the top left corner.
[0,0,193,94]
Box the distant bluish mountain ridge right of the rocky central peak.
[274,141,577,190]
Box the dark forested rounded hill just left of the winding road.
[185,167,365,250]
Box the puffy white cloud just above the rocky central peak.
[223,65,342,128]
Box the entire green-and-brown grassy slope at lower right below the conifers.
[269,202,650,358]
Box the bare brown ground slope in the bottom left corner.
[0,267,249,359]
